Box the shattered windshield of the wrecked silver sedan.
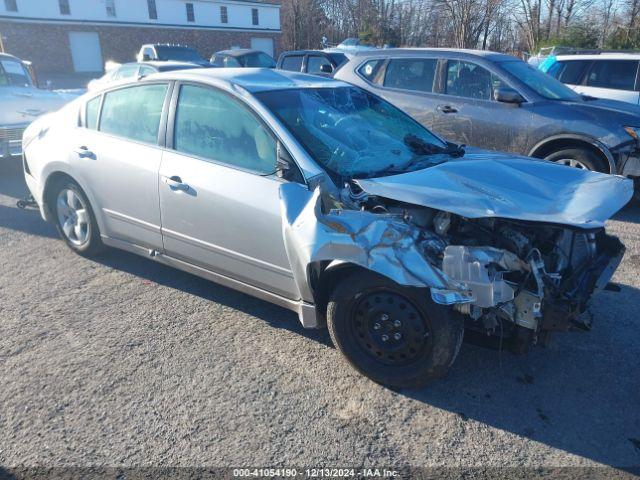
[256,87,461,178]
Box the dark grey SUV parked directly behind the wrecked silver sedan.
[335,49,640,178]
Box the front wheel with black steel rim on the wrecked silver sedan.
[327,271,464,387]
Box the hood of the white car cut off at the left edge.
[0,87,69,126]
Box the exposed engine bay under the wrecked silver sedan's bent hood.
[342,184,625,349]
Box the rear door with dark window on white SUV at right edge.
[575,59,640,104]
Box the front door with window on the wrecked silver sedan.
[159,84,297,298]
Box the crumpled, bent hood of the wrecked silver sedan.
[357,151,633,228]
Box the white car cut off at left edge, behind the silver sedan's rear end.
[0,53,70,160]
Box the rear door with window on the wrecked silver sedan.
[70,83,169,249]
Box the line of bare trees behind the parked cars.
[282,0,640,55]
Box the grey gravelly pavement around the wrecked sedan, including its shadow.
[0,161,640,476]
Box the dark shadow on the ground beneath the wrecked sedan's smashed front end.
[396,285,640,474]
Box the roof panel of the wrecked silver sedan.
[146,68,350,93]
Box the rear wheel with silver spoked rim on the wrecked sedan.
[50,180,104,257]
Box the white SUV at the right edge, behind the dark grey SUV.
[540,53,640,105]
